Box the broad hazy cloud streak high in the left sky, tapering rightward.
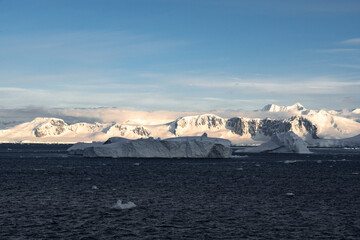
[0,31,192,64]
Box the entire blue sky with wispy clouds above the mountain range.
[0,0,360,111]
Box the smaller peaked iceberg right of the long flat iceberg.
[236,132,311,154]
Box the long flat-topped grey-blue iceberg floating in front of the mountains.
[68,134,232,158]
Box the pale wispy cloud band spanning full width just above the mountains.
[0,72,360,111]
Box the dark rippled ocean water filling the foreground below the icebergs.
[0,144,360,239]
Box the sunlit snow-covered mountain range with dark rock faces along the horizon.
[0,103,360,145]
